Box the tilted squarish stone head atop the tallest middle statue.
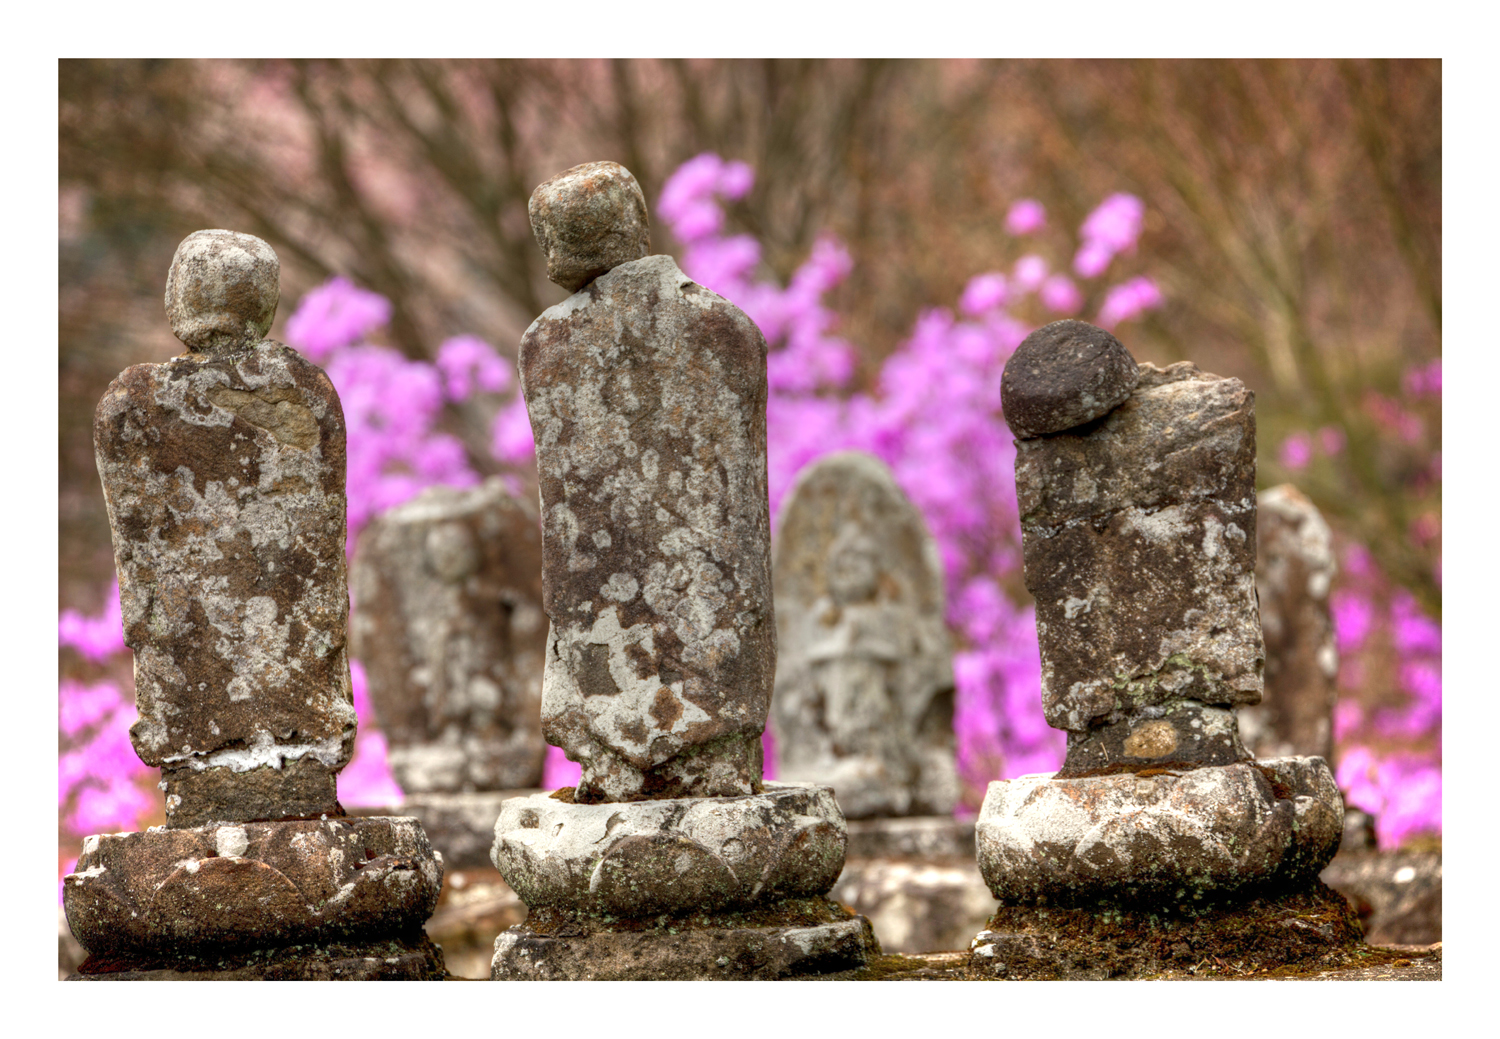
[527,162,651,292]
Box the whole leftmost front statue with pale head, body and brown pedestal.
[65,231,444,979]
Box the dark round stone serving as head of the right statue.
[1001,319,1140,439]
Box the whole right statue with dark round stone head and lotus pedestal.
[972,321,1358,976]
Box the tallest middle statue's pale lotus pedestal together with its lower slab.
[491,783,879,981]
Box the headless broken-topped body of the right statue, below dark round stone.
[1016,361,1263,775]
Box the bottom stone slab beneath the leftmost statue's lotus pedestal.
[68,937,447,981]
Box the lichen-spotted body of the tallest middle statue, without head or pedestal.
[521,256,776,802]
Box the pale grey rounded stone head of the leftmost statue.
[167,231,281,354]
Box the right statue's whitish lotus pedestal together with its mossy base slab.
[969,757,1362,979]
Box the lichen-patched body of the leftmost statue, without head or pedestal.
[95,340,356,826]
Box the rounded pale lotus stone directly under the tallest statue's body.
[492,783,846,922]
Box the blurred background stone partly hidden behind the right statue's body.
[1239,484,1338,757]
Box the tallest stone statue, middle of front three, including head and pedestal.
[492,162,873,979]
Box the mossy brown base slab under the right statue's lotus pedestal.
[969,880,1364,981]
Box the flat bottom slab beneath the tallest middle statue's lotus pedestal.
[491,900,881,981]
